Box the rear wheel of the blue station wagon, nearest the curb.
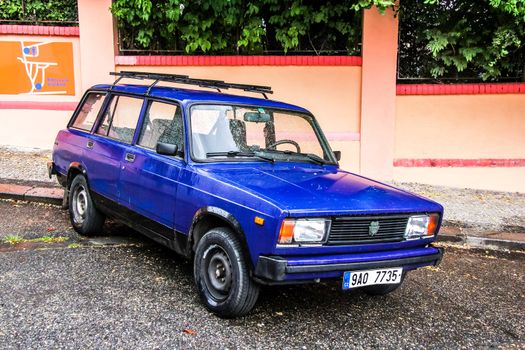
[69,175,106,236]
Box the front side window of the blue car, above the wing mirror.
[138,101,184,151]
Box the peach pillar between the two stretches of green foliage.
[360,8,398,180]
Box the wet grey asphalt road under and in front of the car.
[0,201,525,349]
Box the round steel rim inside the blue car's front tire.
[204,246,232,300]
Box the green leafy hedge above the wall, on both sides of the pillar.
[111,0,525,80]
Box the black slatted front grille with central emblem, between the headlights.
[327,215,408,245]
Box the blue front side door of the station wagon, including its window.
[120,100,185,239]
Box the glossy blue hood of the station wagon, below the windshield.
[200,163,443,216]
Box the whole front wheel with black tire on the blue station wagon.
[193,227,259,318]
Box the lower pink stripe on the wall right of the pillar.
[394,159,525,168]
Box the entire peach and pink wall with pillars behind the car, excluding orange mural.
[0,0,525,192]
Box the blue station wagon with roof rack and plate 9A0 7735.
[48,71,443,317]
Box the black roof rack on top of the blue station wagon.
[109,71,273,99]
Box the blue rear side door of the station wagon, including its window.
[84,95,143,203]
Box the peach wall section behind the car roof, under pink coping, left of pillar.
[116,66,361,172]
